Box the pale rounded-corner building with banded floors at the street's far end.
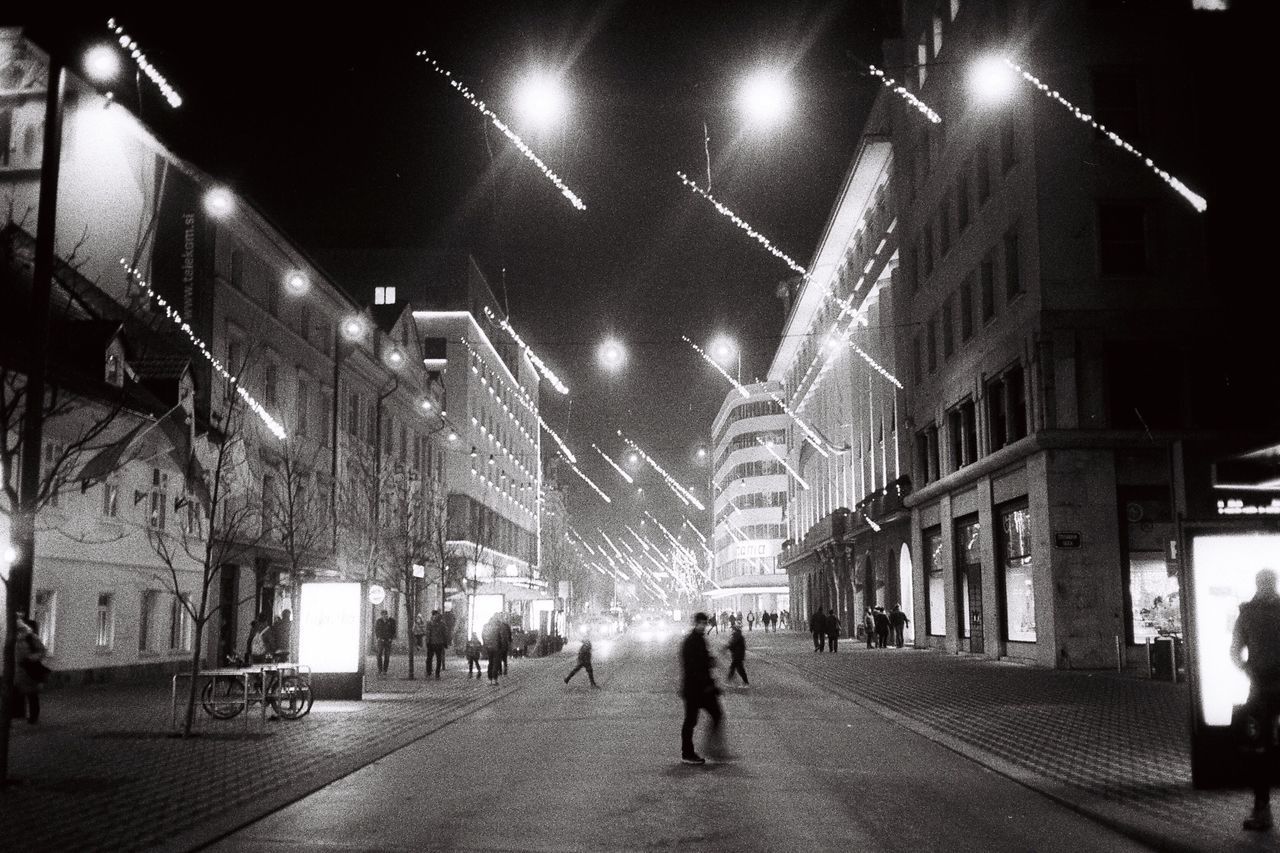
[703,383,791,613]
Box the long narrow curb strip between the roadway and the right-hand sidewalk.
[760,656,1274,853]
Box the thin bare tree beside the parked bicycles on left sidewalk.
[147,382,269,736]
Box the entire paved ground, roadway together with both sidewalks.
[0,631,1272,852]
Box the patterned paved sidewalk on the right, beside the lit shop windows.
[749,634,1277,850]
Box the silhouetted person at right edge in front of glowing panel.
[1231,569,1280,831]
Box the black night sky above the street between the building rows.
[9,0,896,545]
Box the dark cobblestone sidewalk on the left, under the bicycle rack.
[0,648,550,850]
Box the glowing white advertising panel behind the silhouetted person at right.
[1190,533,1280,726]
